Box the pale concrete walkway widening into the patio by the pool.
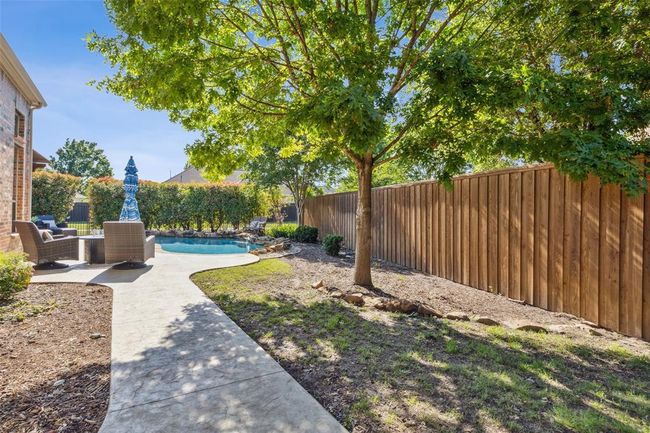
[32,250,346,433]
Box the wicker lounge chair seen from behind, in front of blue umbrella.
[104,221,156,269]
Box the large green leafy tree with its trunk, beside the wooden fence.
[89,0,650,284]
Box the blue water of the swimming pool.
[156,236,262,254]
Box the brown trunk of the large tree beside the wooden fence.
[354,155,373,286]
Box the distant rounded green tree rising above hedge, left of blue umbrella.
[50,138,113,185]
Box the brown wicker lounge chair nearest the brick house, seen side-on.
[14,221,79,269]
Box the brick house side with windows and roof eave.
[0,33,45,251]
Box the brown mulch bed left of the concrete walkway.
[0,283,112,433]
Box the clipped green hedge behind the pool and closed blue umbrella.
[86,178,267,231]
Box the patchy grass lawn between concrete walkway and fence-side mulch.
[193,257,650,433]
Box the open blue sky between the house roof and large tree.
[0,0,197,181]
